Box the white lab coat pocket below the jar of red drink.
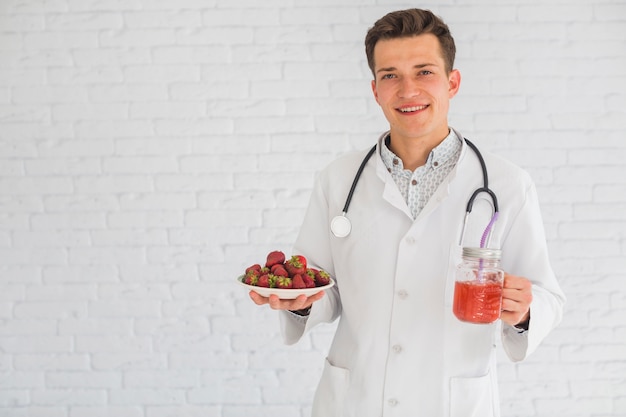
[450,374,496,417]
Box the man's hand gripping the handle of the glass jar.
[500,273,533,326]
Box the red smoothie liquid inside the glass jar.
[453,281,502,323]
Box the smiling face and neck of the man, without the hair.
[372,34,461,142]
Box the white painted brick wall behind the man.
[0,0,626,417]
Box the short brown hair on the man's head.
[365,9,456,77]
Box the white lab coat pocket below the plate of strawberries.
[313,359,350,417]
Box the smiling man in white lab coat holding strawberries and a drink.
[250,9,565,417]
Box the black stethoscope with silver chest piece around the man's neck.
[330,133,499,244]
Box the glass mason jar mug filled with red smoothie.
[452,248,504,324]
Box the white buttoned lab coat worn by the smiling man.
[280,133,565,417]
